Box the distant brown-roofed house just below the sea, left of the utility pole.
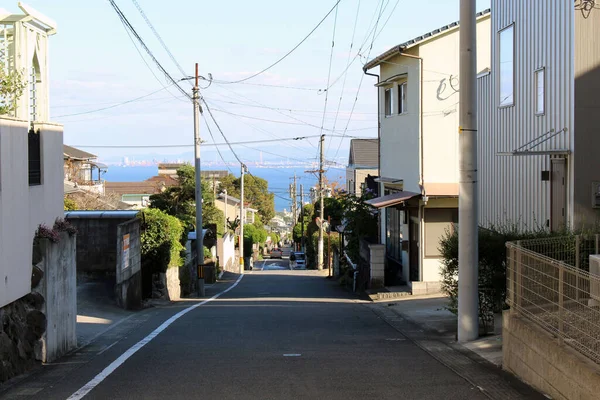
[105,175,179,209]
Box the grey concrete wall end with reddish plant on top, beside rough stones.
[39,232,77,362]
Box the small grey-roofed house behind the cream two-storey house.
[346,139,379,196]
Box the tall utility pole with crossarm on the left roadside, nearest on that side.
[192,63,205,297]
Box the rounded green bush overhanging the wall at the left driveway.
[140,208,185,273]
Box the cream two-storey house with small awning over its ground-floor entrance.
[363,10,490,293]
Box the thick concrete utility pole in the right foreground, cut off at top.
[458,0,479,342]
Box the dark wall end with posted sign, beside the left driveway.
[115,218,142,310]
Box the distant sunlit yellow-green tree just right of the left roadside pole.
[220,174,275,221]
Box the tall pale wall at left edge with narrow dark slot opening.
[0,117,64,307]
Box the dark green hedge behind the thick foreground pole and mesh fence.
[439,225,572,327]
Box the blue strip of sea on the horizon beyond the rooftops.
[103,165,345,211]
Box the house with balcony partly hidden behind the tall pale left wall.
[63,144,108,194]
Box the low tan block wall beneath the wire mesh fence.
[502,310,600,400]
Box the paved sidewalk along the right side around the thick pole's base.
[367,295,545,400]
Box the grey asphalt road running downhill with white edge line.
[0,266,486,400]
